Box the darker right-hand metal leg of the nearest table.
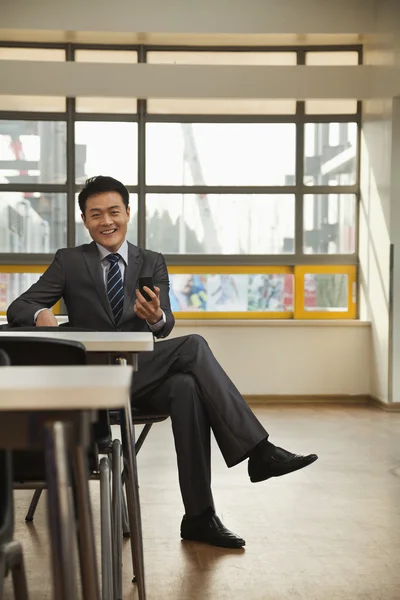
[72,444,100,600]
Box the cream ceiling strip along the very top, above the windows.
[0,0,376,34]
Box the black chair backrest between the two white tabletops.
[0,333,86,366]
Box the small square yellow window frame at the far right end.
[294,265,357,320]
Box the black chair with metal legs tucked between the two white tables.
[0,333,123,597]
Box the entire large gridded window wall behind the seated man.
[0,43,361,319]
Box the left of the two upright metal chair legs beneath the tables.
[100,457,114,600]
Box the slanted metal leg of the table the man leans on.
[121,401,146,600]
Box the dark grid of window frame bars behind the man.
[0,42,362,318]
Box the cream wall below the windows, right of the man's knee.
[167,321,371,396]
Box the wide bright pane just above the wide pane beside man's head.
[146,123,296,185]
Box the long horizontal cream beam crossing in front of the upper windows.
[0,61,400,100]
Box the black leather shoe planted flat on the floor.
[181,513,246,548]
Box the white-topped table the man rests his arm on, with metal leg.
[0,327,154,600]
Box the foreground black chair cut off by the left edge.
[0,348,28,600]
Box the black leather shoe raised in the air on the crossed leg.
[248,446,318,483]
